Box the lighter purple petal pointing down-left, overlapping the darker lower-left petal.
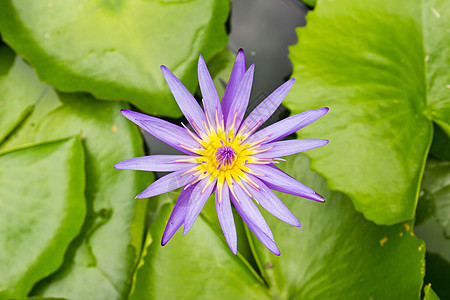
[183,177,217,235]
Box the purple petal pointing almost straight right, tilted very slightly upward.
[255,139,328,158]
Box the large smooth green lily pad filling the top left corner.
[0,0,229,117]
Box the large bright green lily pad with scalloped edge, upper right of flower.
[285,0,450,225]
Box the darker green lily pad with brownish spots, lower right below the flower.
[246,155,425,299]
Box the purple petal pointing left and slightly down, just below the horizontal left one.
[136,167,194,199]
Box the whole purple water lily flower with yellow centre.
[114,50,328,255]
